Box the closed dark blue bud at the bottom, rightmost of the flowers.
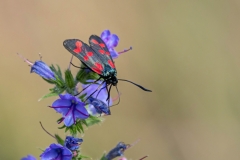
[105,142,129,160]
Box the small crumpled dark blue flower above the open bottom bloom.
[64,136,83,151]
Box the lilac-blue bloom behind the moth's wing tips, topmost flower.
[101,30,132,59]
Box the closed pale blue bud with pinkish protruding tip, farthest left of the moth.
[18,54,56,80]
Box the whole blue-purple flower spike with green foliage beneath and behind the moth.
[18,30,146,160]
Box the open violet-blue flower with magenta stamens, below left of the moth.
[51,93,89,127]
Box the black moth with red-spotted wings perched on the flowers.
[63,35,152,103]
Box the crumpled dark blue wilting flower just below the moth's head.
[87,97,111,115]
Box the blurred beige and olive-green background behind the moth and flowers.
[0,0,240,160]
